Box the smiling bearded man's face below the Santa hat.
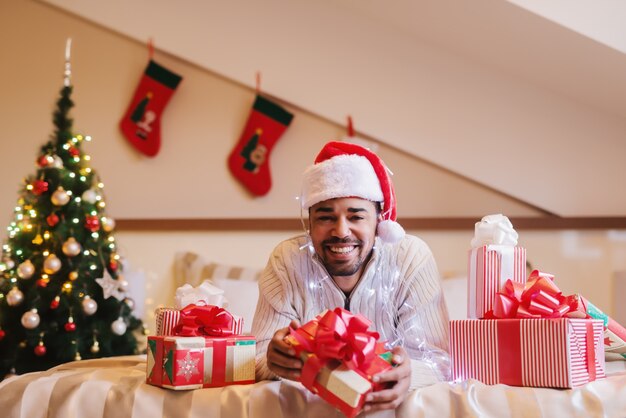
[309,197,378,278]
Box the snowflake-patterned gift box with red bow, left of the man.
[146,305,256,390]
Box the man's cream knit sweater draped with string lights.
[252,235,449,388]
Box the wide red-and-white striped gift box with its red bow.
[450,270,605,388]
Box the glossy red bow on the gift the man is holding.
[291,308,379,385]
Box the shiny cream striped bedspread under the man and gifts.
[0,356,626,418]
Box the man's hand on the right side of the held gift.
[363,347,411,411]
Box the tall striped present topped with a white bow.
[467,215,526,318]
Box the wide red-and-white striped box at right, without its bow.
[450,318,606,388]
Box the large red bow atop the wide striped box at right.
[485,270,589,319]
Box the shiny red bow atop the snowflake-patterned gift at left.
[174,304,234,337]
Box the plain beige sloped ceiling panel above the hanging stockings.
[37,0,626,216]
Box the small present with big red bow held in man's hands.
[285,308,392,417]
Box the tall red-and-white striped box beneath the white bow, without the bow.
[467,245,526,319]
